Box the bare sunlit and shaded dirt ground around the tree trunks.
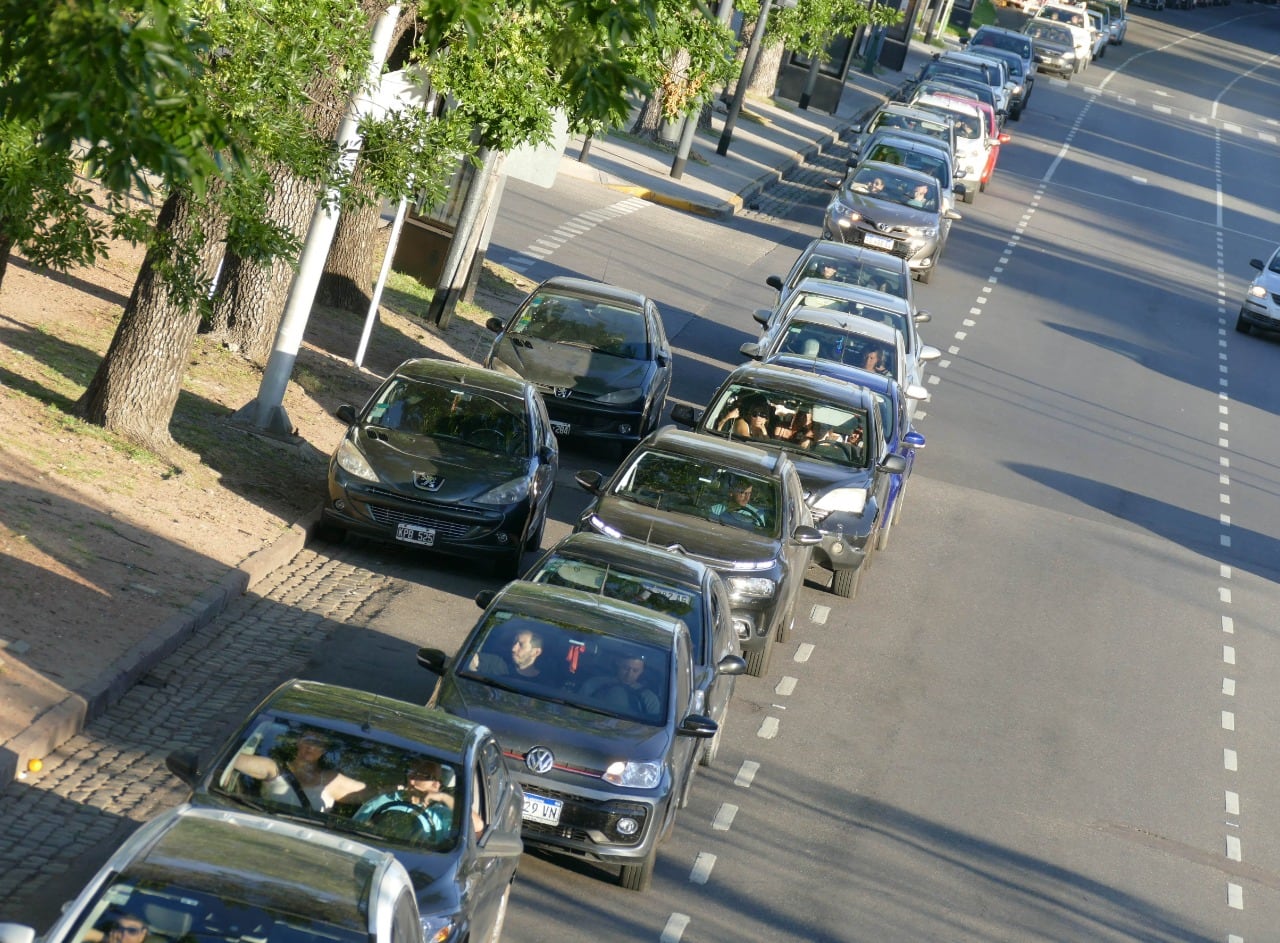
[0,230,532,690]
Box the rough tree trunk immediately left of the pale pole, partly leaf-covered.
[210,166,316,363]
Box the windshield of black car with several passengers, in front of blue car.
[705,384,868,468]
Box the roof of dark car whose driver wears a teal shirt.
[262,679,485,763]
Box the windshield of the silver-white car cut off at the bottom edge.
[58,862,372,943]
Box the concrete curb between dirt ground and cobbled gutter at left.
[0,508,320,783]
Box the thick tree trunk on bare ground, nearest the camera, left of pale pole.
[77,192,225,452]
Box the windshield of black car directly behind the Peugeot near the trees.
[509,292,650,360]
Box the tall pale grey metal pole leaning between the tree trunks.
[236,3,401,435]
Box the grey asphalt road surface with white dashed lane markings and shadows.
[10,4,1280,943]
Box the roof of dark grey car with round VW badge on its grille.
[481,580,689,647]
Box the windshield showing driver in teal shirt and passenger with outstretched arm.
[210,714,465,852]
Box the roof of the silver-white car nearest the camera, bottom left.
[119,806,397,934]
